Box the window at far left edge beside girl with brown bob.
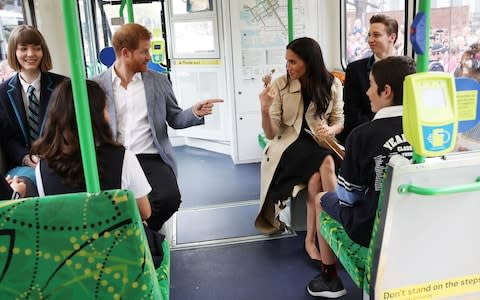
[0,1,25,82]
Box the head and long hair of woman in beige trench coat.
[285,37,333,114]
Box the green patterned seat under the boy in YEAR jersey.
[319,179,383,294]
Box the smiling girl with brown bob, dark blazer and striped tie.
[0,25,65,182]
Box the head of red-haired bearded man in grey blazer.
[112,23,152,72]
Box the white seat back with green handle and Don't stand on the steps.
[370,151,480,299]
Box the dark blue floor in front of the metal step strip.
[170,232,362,300]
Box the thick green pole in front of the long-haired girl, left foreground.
[62,0,100,193]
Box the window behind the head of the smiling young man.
[343,0,406,64]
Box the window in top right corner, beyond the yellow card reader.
[429,0,480,76]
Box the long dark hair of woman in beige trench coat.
[287,37,333,116]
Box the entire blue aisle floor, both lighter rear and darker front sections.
[170,147,362,300]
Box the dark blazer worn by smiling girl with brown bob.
[0,72,66,168]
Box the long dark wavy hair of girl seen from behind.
[30,79,118,187]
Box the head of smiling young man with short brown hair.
[368,15,398,58]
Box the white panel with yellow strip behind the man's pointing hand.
[166,0,231,146]
